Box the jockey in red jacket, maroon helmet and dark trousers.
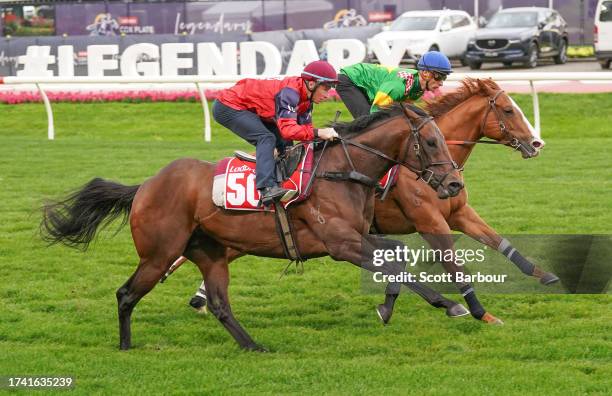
[213,61,338,205]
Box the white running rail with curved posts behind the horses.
[0,72,612,142]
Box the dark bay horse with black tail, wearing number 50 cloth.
[41,105,463,350]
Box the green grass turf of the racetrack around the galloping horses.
[0,94,612,395]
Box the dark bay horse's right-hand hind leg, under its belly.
[185,235,266,352]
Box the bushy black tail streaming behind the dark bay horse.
[40,178,140,250]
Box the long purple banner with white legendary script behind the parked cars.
[0,0,597,44]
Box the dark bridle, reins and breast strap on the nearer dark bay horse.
[313,105,459,193]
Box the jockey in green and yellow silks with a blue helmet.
[336,51,452,118]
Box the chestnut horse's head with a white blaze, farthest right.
[477,79,544,158]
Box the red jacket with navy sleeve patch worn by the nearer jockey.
[217,77,314,141]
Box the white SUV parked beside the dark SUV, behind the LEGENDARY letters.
[371,10,478,62]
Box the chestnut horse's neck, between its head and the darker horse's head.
[435,95,484,165]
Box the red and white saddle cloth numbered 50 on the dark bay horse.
[212,143,314,211]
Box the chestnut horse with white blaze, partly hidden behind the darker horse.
[374,79,558,323]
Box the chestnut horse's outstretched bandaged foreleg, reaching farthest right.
[448,205,559,285]
